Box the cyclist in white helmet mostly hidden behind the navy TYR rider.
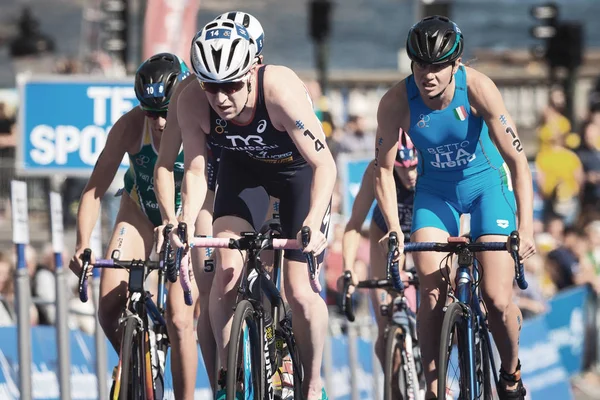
[154,12,272,399]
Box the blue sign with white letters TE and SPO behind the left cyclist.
[17,76,138,176]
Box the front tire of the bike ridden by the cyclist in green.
[119,318,146,400]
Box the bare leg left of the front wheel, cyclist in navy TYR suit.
[208,216,254,369]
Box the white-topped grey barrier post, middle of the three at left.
[50,192,71,400]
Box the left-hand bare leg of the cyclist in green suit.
[98,193,154,354]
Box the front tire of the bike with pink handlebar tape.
[225,300,264,400]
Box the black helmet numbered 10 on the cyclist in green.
[134,53,190,111]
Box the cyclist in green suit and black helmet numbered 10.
[69,53,195,396]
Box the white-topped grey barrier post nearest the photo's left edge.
[10,181,32,399]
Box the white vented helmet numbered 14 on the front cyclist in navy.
[190,20,256,83]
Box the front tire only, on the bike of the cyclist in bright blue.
[437,303,471,400]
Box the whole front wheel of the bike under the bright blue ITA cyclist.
[437,303,472,400]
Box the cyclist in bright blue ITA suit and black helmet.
[375,16,535,400]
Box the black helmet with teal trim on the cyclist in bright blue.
[406,15,464,64]
